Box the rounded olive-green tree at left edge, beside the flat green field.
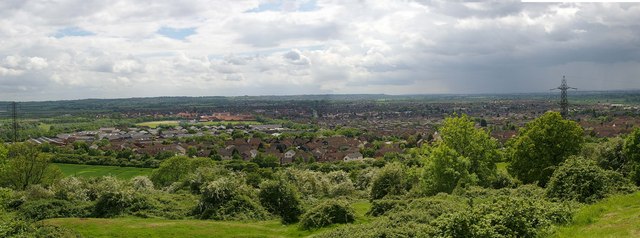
[0,143,63,190]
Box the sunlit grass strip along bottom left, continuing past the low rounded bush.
[44,201,371,237]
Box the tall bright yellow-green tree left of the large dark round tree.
[439,115,500,187]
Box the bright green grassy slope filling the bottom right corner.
[553,192,640,237]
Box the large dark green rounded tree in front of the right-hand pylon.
[508,112,584,187]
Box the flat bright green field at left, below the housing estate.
[55,163,153,179]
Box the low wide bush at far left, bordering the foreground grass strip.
[18,199,89,221]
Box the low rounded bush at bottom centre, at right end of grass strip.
[300,200,355,230]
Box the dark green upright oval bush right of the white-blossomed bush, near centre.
[258,180,302,224]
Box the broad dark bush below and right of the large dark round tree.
[546,157,634,203]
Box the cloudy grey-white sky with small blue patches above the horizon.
[0,0,640,101]
